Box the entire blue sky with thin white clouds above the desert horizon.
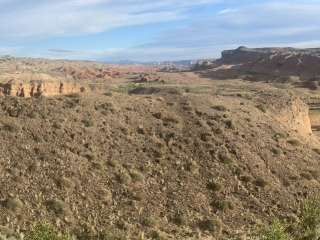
[0,0,320,62]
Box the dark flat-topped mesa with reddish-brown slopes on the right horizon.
[199,47,320,85]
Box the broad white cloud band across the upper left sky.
[0,0,217,39]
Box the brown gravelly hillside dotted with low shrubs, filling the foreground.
[0,59,320,239]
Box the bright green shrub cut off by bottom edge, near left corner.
[25,224,72,240]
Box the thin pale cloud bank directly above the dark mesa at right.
[140,0,320,57]
